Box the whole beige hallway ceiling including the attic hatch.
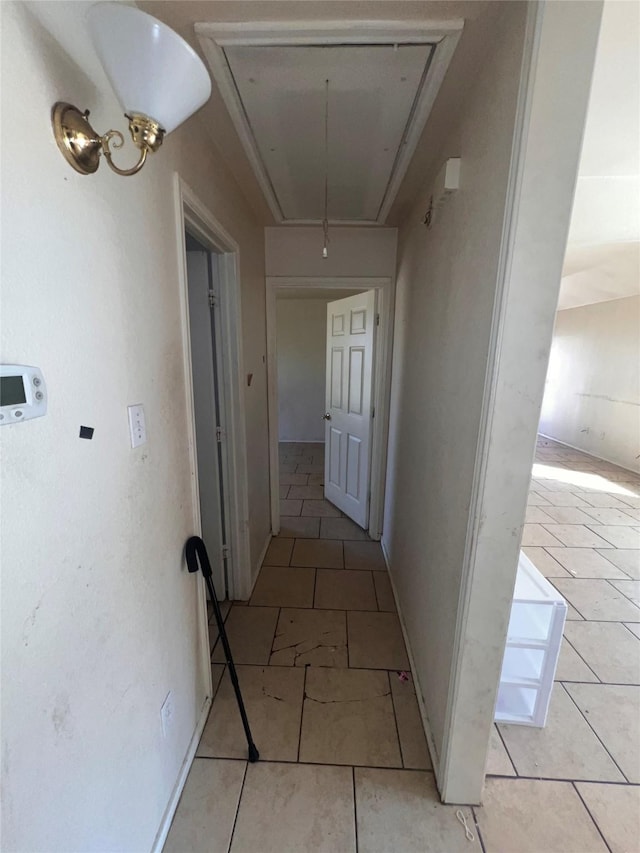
[137,0,490,225]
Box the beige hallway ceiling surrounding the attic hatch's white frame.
[138,0,490,225]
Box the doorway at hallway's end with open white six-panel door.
[267,277,393,540]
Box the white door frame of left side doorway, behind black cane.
[174,172,251,612]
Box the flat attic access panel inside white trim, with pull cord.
[224,43,435,222]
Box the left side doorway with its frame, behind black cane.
[175,175,251,612]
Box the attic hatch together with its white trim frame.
[195,20,463,225]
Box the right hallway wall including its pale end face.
[383,2,602,803]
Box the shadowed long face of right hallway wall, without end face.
[383,3,526,768]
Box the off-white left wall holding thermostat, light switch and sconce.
[0,2,269,853]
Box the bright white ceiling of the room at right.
[558,0,640,310]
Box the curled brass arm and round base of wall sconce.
[51,101,164,176]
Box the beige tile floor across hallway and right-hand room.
[165,438,640,853]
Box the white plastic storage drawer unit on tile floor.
[495,552,567,727]
